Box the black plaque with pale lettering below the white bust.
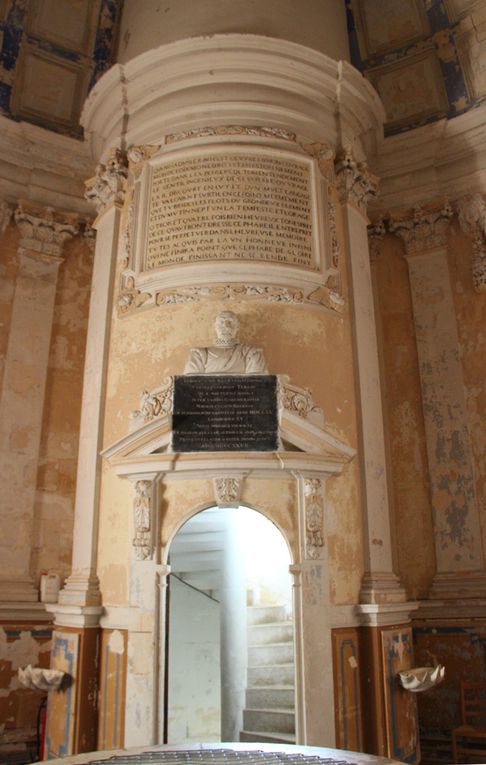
[172,375,278,452]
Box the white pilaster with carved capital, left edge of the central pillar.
[51,151,127,625]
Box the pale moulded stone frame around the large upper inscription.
[125,135,332,295]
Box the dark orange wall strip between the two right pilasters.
[372,237,435,599]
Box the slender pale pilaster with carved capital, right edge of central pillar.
[336,149,405,604]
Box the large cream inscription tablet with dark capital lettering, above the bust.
[142,151,317,271]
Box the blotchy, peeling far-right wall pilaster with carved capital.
[389,205,486,598]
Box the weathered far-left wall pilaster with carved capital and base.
[0,203,78,602]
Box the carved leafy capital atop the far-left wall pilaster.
[14,201,79,258]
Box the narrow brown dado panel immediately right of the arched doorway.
[332,627,363,752]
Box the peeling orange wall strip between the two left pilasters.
[32,237,93,577]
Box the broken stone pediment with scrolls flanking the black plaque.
[103,375,356,475]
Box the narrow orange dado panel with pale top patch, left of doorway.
[98,630,127,749]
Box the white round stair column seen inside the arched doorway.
[219,508,247,741]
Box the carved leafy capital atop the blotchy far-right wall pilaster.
[388,201,454,255]
